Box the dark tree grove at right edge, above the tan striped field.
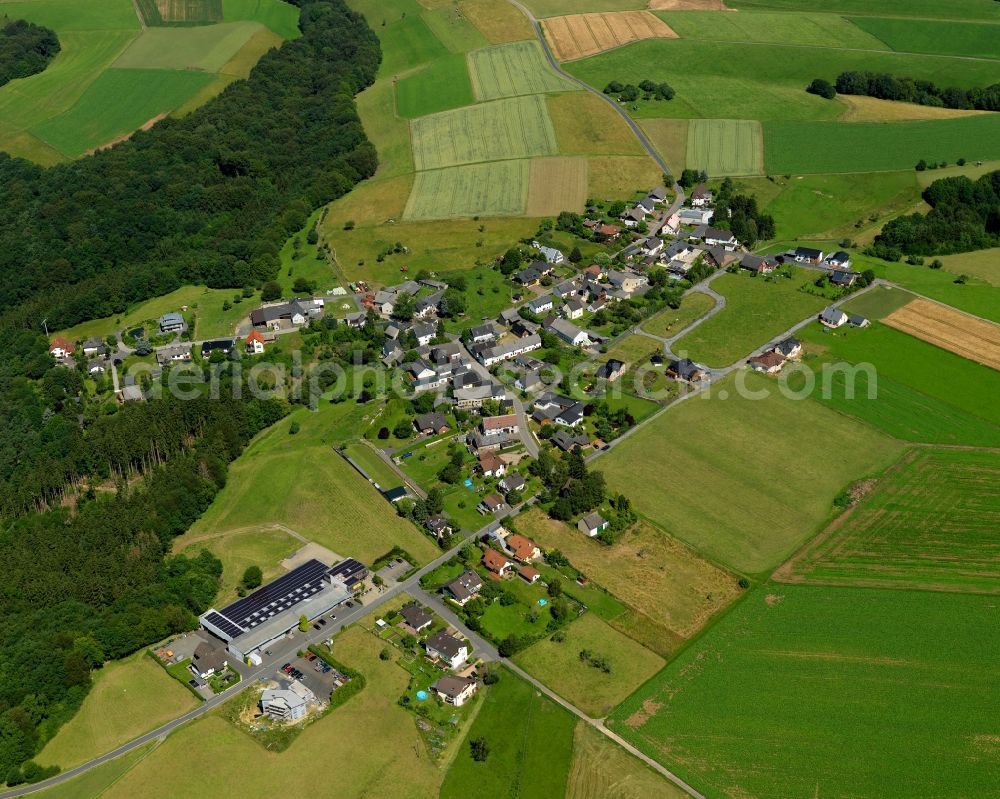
[868,170,1000,261]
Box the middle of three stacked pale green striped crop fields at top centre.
[411,95,557,170]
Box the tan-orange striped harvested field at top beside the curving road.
[542,11,677,61]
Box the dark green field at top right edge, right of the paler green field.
[851,17,1000,58]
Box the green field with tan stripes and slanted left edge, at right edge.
[776,449,1000,594]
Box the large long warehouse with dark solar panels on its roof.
[200,559,368,660]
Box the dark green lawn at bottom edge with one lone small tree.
[441,669,575,799]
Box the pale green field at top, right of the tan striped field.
[657,10,896,50]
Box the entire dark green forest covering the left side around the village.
[0,0,381,784]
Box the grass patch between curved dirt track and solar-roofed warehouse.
[174,528,303,607]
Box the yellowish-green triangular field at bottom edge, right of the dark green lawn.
[566,721,687,799]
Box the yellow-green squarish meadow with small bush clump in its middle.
[514,613,664,718]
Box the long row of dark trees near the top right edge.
[806,70,1000,111]
